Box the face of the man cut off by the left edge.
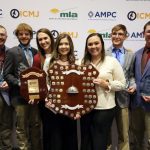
[0,27,7,48]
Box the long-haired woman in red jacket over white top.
[33,28,54,150]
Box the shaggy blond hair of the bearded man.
[15,23,33,38]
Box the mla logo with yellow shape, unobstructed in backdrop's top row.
[49,8,78,20]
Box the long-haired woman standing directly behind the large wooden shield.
[47,34,78,150]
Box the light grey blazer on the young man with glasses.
[106,47,135,108]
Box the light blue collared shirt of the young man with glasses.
[112,46,125,66]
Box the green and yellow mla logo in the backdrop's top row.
[50,8,78,19]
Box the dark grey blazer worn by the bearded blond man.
[4,46,37,104]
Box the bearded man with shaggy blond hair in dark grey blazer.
[4,23,41,150]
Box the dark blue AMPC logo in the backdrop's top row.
[88,11,117,20]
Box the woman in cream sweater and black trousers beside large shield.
[81,33,125,150]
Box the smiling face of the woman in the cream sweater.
[87,35,102,57]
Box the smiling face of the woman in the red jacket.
[37,32,51,53]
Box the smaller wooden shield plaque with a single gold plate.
[20,67,48,102]
